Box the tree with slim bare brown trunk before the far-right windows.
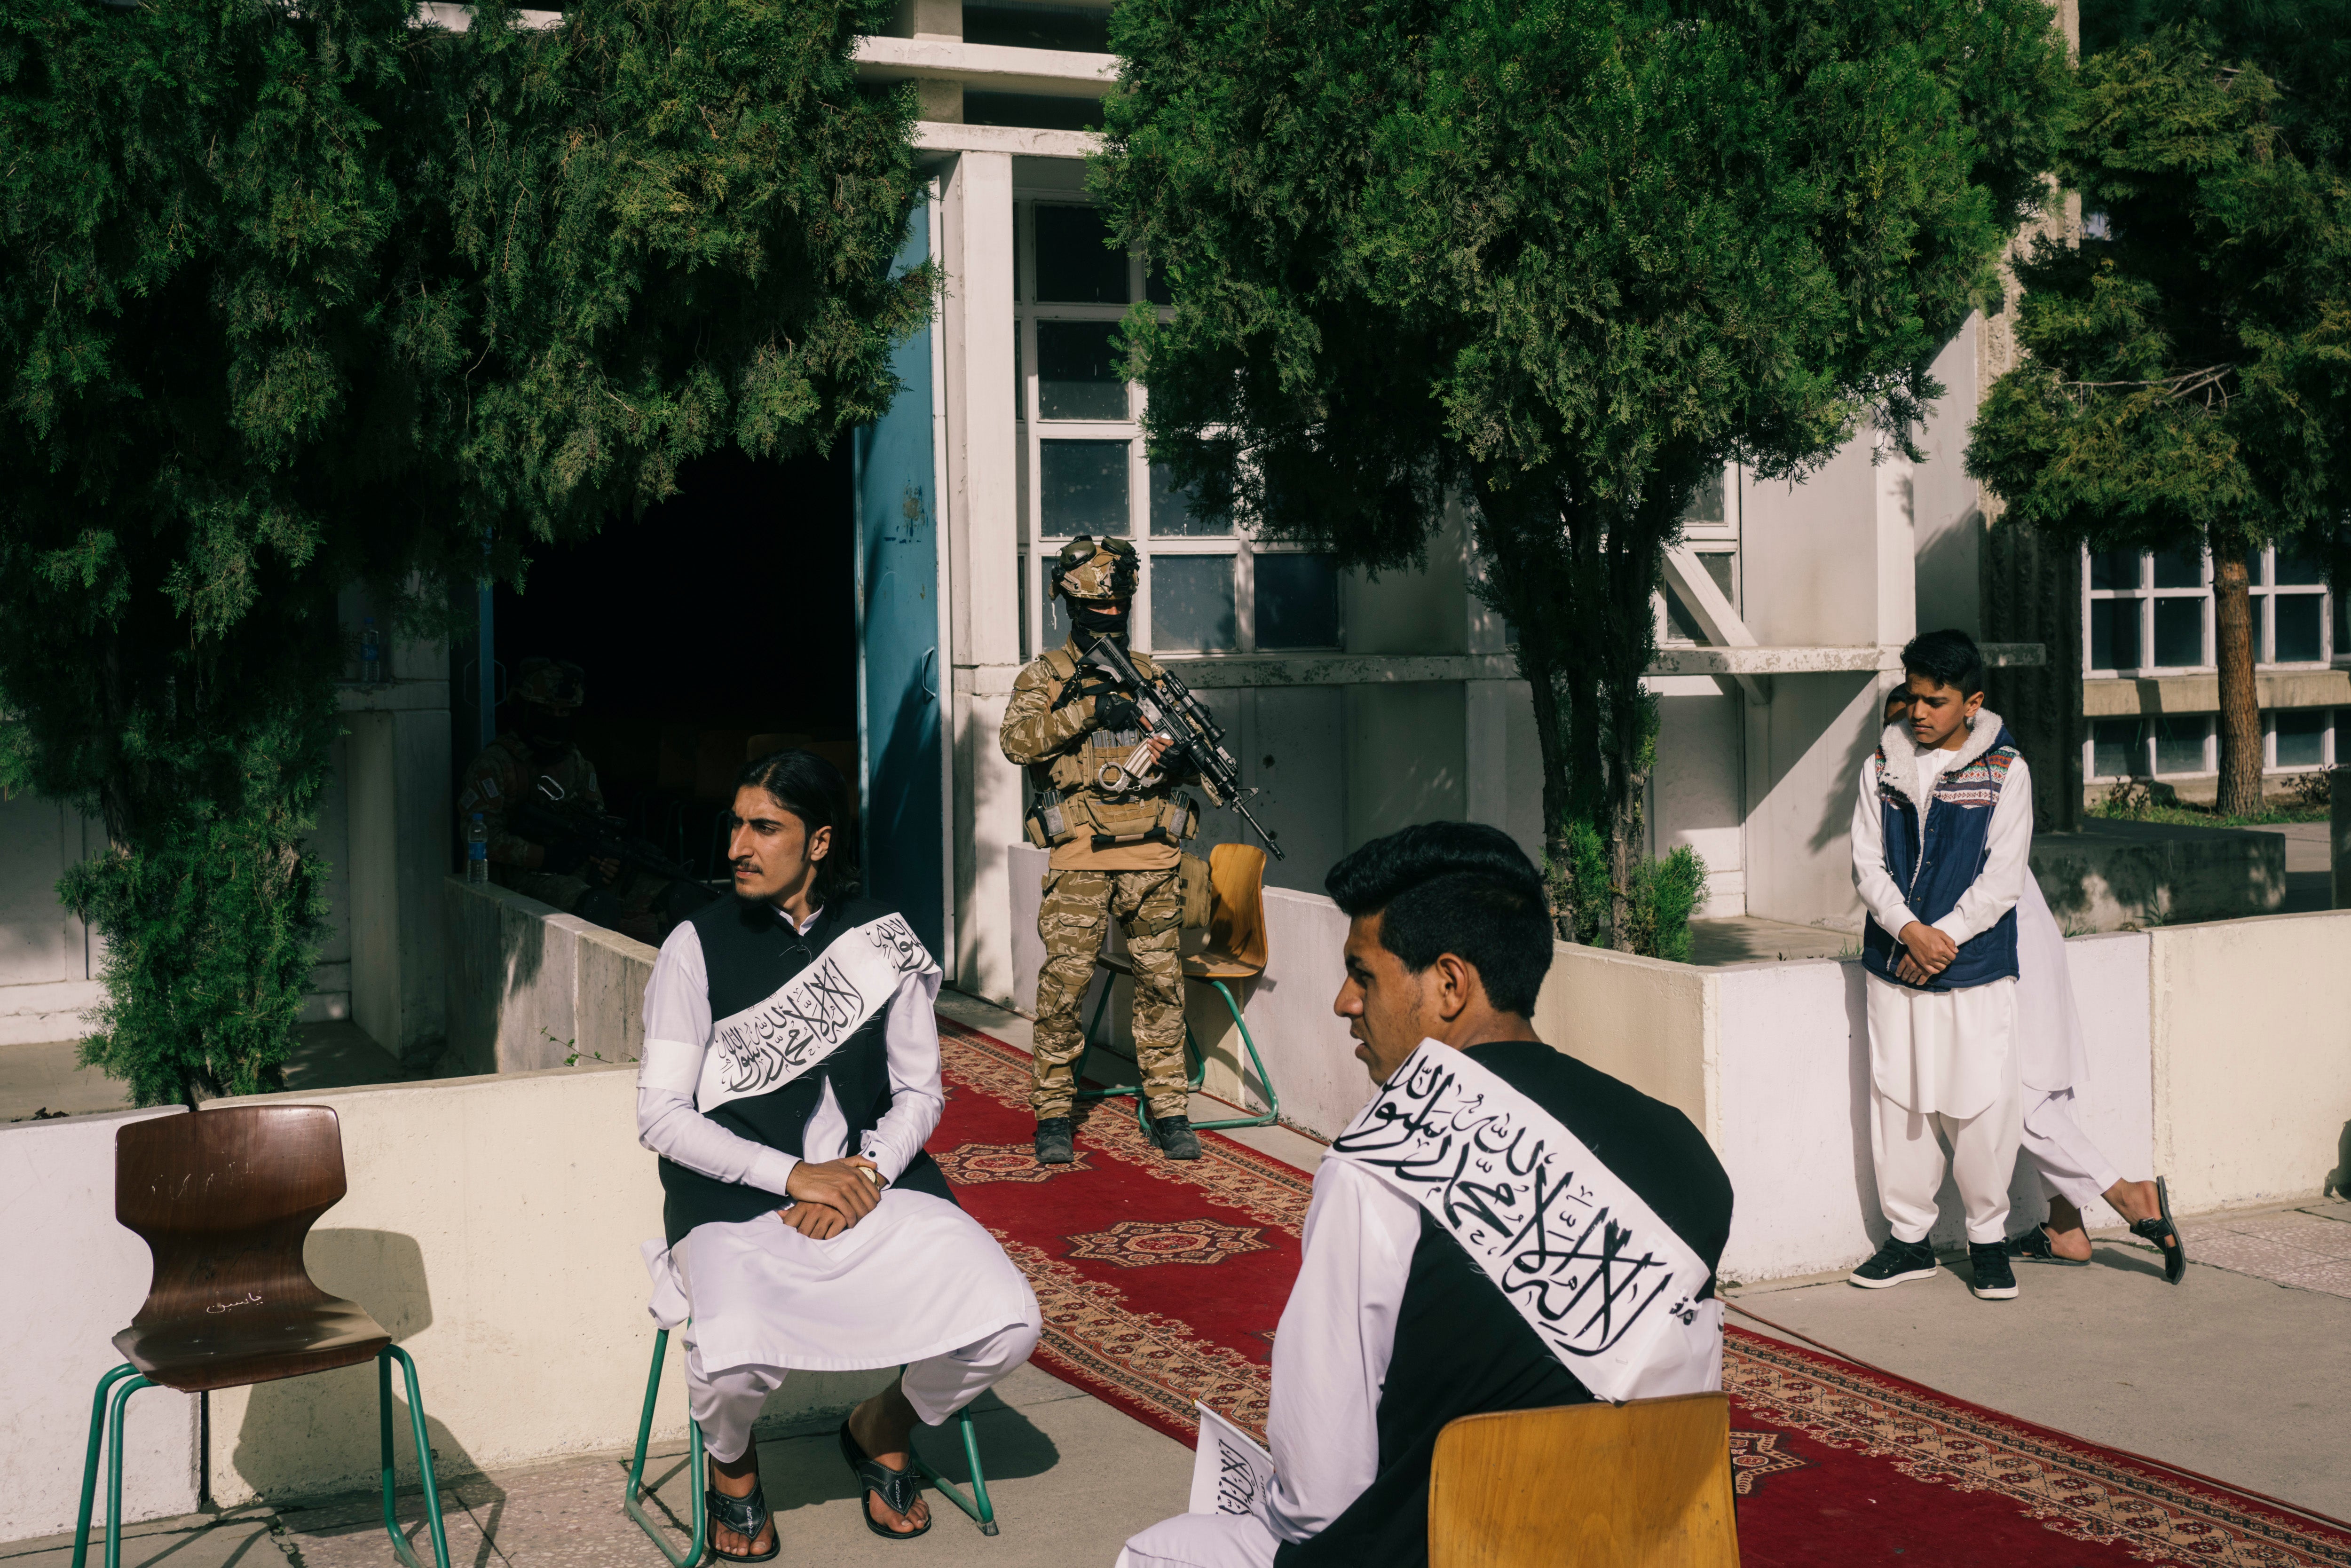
[1968,24,2351,816]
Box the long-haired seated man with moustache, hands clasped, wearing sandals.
[637,752,1041,1563]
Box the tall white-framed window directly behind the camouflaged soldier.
[1013,195,1340,658]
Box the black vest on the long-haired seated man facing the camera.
[661,898,955,1246]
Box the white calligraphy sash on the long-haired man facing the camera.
[694,914,936,1114]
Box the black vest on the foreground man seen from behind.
[1274,1041,1730,1568]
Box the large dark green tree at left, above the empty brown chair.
[0,0,929,1105]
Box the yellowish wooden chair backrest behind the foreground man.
[1429,1394,1740,1568]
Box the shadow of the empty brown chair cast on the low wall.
[230,1229,491,1502]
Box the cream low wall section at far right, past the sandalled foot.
[2154,910,2351,1208]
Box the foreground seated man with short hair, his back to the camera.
[1119,823,1730,1568]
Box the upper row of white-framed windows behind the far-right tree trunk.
[2083,550,2337,675]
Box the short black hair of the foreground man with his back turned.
[1324,823,1552,1018]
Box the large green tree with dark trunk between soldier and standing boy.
[1096,0,2064,936]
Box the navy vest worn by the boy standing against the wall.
[1862,724,2031,992]
